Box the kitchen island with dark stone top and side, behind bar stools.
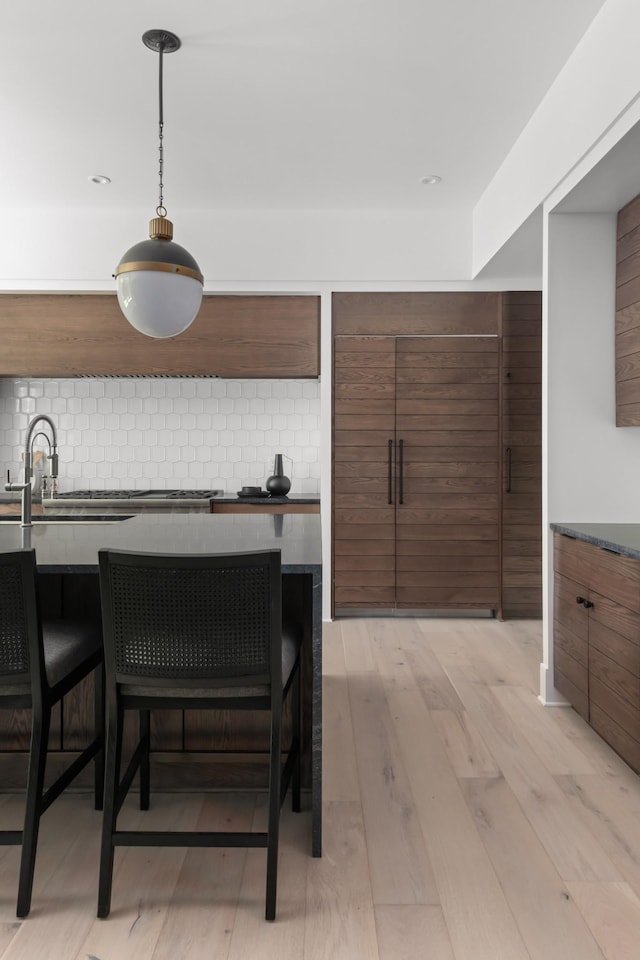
[0,514,322,856]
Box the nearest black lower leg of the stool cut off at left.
[16,704,51,917]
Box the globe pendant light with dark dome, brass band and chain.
[114,30,204,338]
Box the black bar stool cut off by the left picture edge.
[0,550,104,917]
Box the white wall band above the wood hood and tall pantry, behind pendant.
[0,207,471,292]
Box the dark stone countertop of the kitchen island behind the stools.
[0,513,322,575]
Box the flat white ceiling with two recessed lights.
[0,0,604,217]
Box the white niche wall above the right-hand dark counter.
[546,214,640,523]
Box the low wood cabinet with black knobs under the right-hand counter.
[553,533,640,772]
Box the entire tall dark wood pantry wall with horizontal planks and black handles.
[332,292,541,617]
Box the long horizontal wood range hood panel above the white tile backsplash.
[0,294,320,378]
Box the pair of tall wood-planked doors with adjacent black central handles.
[333,336,500,615]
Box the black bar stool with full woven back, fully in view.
[98,549,301,920]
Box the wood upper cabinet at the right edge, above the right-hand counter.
[616,196,640,427]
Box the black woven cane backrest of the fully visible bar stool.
[102,551,280,687]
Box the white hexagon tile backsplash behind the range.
[0,377,320,496]
